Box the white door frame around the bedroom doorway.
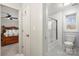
[0,4,22,56]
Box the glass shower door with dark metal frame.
[48,19,57,44]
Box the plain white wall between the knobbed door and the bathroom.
[30,3,43,56]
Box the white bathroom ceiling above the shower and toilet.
[47,3,79,16]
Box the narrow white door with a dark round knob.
[23,4,30,56]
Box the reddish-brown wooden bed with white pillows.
[1,26,19,46]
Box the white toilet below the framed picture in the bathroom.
[64,35,75,54]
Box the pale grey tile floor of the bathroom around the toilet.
[46,40,79,56]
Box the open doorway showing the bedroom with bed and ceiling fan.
[0,5,19,56]
